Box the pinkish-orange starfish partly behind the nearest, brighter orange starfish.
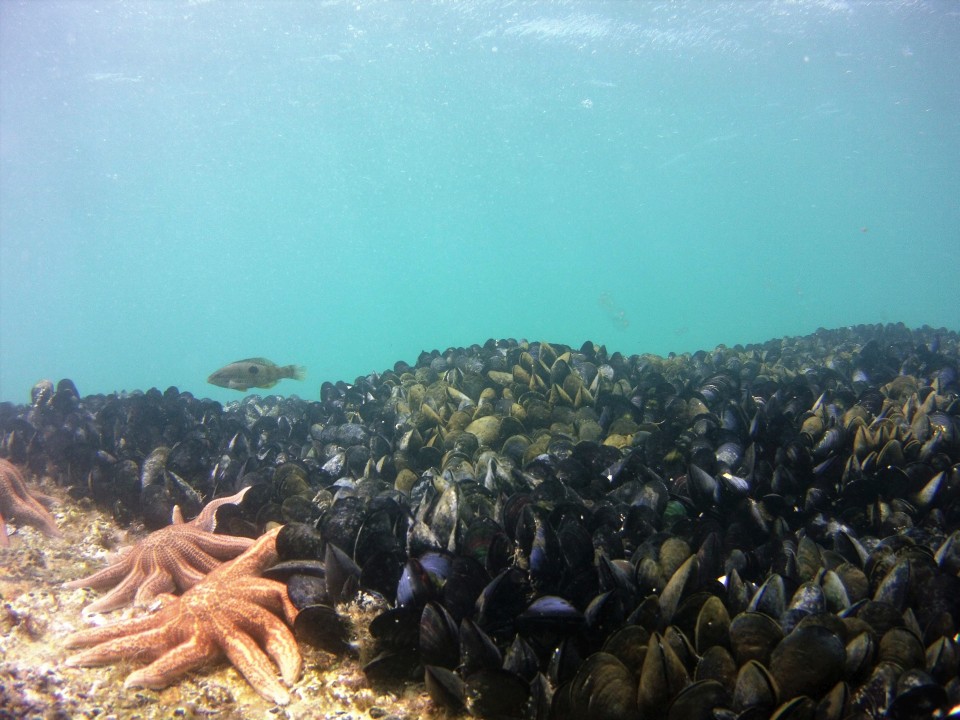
[64,488,253,613]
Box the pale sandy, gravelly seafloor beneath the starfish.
[0,479,446,720]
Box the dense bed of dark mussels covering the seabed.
[0,325,960,720]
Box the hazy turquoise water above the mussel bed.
[0,0,960,402]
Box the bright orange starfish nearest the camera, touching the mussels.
[66,528,303,705]
